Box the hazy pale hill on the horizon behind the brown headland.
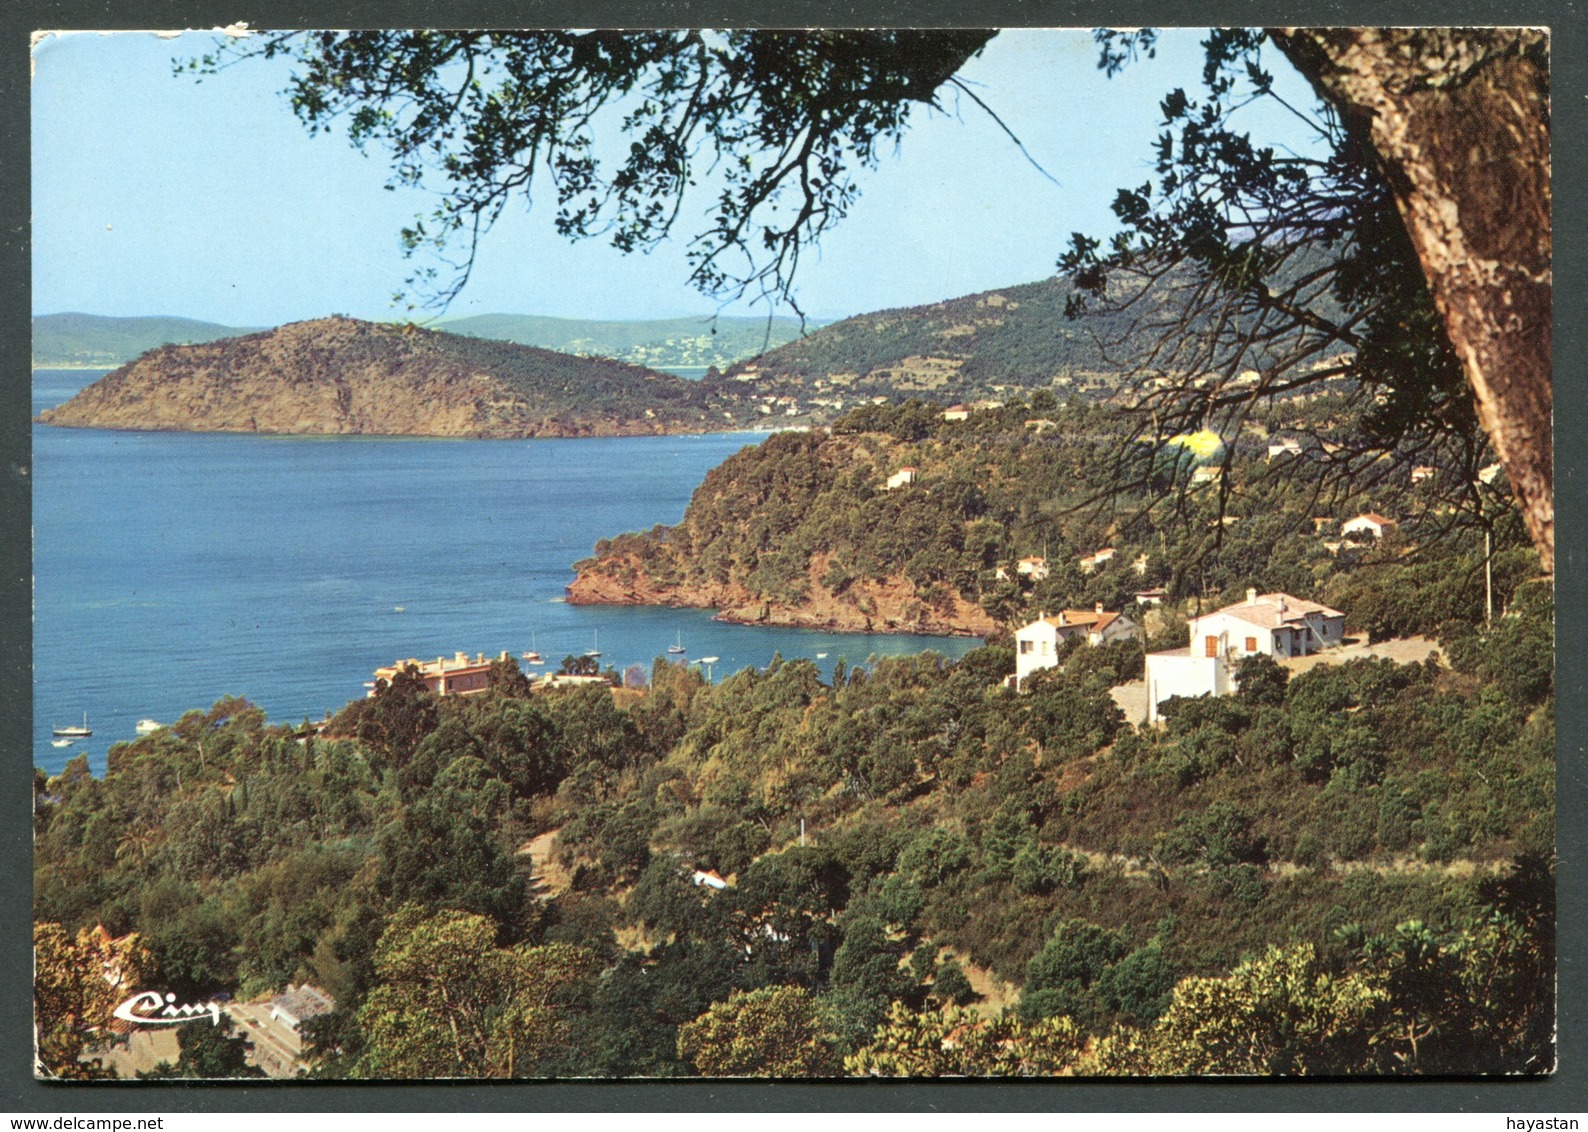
[440,314,819,370]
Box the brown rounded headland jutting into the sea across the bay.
[40,318,754,437]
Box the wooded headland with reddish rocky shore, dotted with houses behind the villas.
[569,391,1536,643]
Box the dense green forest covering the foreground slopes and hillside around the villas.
[35,399,1555,1078]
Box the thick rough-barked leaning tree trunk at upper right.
[1269,27,1555,572]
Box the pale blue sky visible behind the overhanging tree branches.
[32,30,1327,325]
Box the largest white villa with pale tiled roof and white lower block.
[1137,589,1345,722]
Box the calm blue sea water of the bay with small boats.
[33,370,975,773]
